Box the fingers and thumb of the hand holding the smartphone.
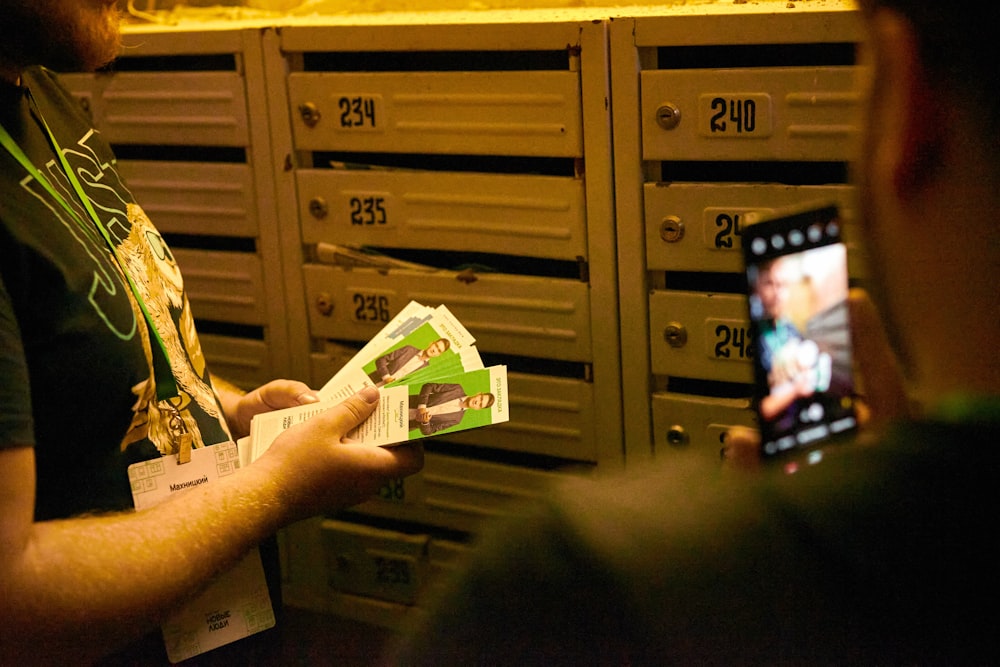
[723,289,910,470]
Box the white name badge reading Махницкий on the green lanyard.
[128,442,275,663]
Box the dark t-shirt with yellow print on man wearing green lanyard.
[0,68,229,519]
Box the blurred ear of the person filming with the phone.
[871,9,948,200]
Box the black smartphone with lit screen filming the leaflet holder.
[742,204,858,463]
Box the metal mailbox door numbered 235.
[296,169,587,260]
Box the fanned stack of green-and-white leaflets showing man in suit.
[238,301,509,465]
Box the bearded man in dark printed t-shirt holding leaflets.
[0,0,422,665]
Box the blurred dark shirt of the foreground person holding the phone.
[394,414,1000,667]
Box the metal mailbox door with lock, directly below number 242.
[652,392,755,461]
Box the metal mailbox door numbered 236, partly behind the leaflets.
[303,264,591,362]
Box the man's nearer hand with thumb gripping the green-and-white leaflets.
[249,387,424,519]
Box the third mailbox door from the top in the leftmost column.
[173,248,267,324]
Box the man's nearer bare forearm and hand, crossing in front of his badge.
[0,388,422,664]
